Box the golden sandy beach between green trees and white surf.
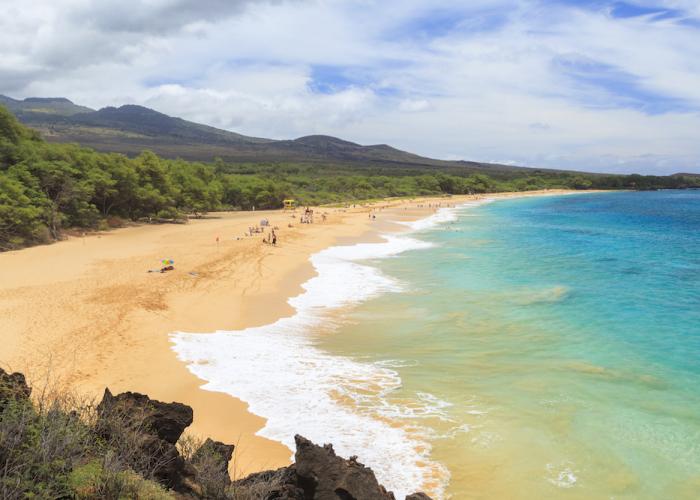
[0,191,580,477]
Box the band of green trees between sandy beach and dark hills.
[0,106,700,251]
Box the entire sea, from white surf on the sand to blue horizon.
[172,191,700,499]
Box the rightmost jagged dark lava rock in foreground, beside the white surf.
[234,435,430,500]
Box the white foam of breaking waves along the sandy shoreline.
[171,208,478,498]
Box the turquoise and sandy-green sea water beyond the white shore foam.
[319,191,700,499]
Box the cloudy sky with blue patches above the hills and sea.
[0,0,700,173]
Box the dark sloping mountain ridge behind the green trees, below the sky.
[0,96,529,173]
